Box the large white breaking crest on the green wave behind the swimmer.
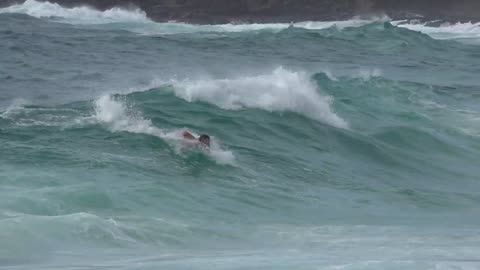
[167,67,348,128]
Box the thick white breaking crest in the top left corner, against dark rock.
[0,0,152,24]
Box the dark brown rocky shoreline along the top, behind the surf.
[0,0,480,24]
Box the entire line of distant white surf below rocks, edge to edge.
[0,0,480,43]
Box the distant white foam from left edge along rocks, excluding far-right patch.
[0,0,380,35]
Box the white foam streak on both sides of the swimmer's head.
[94,95,235,165]
